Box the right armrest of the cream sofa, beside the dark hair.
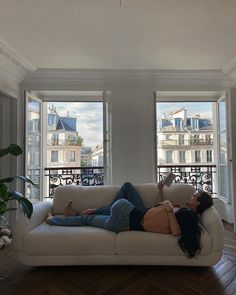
[200,206,224,252]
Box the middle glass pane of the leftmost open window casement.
[27,134,40,167]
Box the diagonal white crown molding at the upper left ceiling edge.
[0,38,36,80]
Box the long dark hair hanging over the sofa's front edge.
[175,208,201,258]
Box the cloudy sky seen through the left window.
[48,102,103,148]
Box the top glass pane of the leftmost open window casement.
[27,98,41,132]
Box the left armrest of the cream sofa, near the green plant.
[12,201,52,252]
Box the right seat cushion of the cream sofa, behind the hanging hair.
[116,231,212,255]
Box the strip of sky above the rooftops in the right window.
[157,102,212,120]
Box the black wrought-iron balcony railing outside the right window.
[157,165,217,194]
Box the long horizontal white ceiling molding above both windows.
[22,69,235,90]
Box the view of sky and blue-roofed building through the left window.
[47,102,103,167]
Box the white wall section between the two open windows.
[111,85,155,184]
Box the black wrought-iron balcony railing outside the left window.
[45,166,104,198]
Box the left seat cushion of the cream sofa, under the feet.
[23,223,116,256]
